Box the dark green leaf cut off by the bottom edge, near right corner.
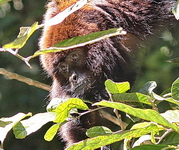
[131,145,174,150]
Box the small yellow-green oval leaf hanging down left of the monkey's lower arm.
[44,124,60,141]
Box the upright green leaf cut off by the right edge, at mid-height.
[171,78,179,100]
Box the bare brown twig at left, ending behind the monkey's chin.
[0,68,50,91]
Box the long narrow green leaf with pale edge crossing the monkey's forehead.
[30,28,125,58]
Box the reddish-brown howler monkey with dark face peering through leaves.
[40,0,176,149]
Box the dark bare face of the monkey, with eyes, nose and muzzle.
[54,49,96,98]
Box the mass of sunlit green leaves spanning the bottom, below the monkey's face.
[0,78,179,150]
